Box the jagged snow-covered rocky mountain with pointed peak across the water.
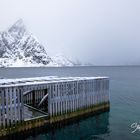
[0,19,73,67]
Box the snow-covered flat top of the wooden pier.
[0,76,108,87]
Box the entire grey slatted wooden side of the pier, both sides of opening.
[0,78,109,128]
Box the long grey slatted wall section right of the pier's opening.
[49,78,109,116]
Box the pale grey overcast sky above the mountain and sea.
[0,0,140,65]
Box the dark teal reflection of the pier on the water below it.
[3,112,109,140]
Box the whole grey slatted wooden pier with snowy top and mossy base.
[0,76,109,136]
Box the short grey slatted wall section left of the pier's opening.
[0,87,24,128]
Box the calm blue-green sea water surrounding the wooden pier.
[0,66,140,140]
